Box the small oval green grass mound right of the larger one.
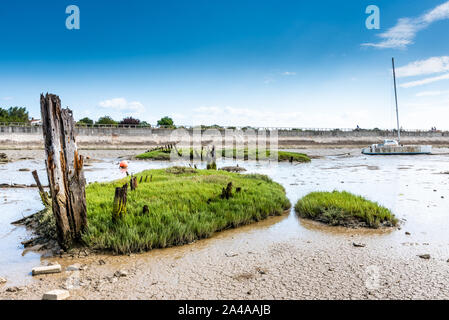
[295,191,398,228]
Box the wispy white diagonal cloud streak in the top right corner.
[362,1,449,49]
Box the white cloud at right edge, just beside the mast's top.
[396,56,449,77]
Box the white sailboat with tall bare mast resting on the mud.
[362,58,432,155]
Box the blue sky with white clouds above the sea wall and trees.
[0,0,449,129]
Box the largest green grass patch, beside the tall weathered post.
[83,167,290,253]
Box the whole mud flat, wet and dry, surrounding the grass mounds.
[0,149,449,299]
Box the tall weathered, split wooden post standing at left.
[41,93,87,249]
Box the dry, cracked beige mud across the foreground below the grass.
[0,149,449,299]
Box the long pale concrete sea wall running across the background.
[0,125,449,149]
